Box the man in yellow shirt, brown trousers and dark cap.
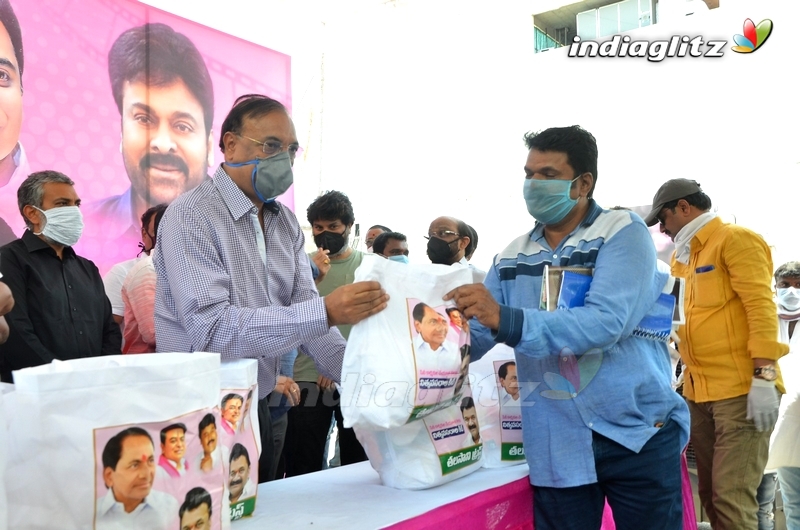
[645,179,788,529]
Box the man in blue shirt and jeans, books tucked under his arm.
[445,126,689,530]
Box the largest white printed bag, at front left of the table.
[5,353,225,529]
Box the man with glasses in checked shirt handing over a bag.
[154,95,389,479]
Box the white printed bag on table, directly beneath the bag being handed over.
[355,385,484,490]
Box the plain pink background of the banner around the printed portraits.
[0,0,294,273]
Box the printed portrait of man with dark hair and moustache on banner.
[95,23,214,241]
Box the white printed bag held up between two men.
[341,256,473,429]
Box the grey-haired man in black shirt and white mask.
[0,171,122,383]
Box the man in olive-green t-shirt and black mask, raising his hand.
[285,191,367,477]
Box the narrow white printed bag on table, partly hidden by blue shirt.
[469,344,525,467]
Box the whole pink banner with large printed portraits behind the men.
[6,0,294,275]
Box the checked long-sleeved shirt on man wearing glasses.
[153,165,345,399]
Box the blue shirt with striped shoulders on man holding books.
[470,201,689,488]
